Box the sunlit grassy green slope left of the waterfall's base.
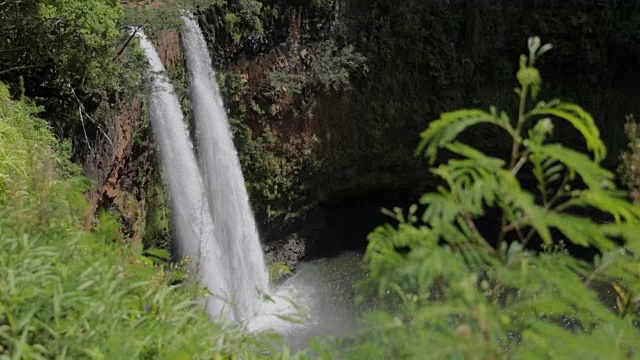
[0,84,296,359]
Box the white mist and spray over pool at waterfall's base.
[248,252,371,349]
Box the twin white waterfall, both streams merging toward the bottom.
[139,17,268,321]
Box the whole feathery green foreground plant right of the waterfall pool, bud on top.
[345,37,640,358]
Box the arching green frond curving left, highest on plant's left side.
[416,108,512,164]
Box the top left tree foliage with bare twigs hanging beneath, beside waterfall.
[0,0,145,154]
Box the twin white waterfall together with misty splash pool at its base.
[139,17,370,347]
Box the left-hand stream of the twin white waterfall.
[139,34,228,314]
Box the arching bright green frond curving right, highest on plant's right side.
[525,100,607,162]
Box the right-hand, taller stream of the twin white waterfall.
[182,16,268,320]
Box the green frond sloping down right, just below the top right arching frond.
[525,142,614,190]
